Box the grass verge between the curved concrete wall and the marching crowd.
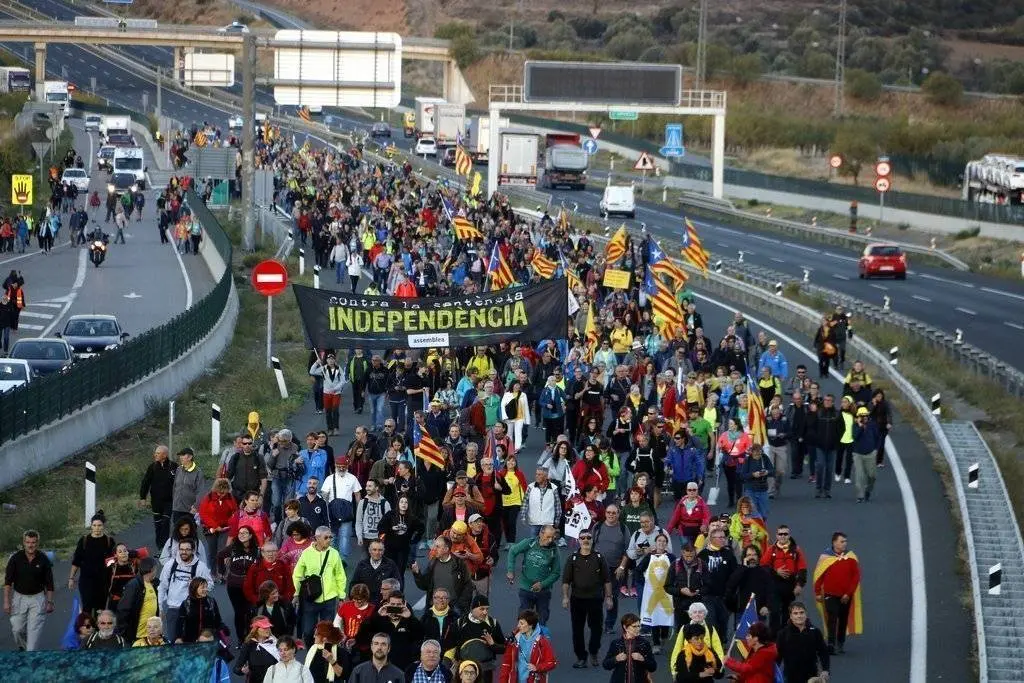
[0,215,311,554]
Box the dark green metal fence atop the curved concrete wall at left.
[0,188,231,443]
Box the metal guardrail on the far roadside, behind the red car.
[680,194,971,270]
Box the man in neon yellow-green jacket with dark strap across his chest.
[292,526,348,643]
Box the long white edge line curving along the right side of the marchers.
[694,294,928,683]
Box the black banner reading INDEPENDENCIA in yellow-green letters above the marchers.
[292,279,568,348]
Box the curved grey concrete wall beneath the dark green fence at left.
[0,282,239,489]
